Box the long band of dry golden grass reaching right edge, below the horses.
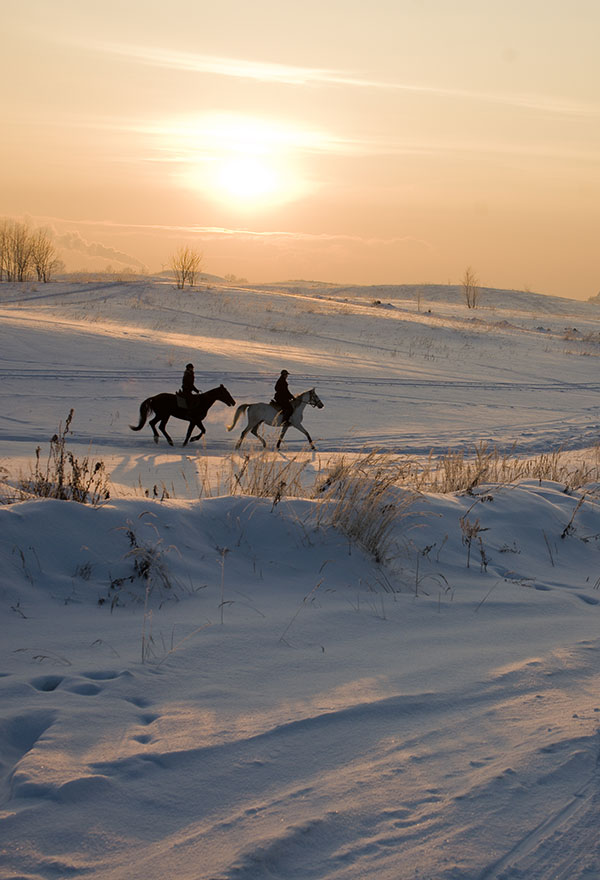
[193,443,600,562]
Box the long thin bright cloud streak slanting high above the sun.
[90,43,600,117]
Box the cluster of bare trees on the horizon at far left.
[0,219,62,282]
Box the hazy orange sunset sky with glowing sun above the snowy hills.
[0,0,600,299]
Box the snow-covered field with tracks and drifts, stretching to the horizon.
[0,279,600,880]
